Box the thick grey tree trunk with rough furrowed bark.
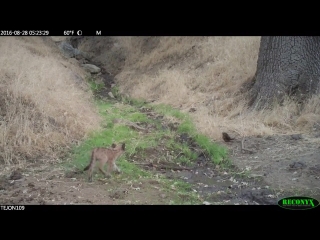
[250,36,320,109]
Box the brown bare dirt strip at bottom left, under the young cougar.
[0,165,178,205]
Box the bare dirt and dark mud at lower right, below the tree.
[159,128,320,204]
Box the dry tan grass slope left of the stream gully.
[0,37,100,164]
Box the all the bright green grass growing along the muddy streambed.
[64,85,232,204]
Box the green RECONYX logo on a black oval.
[278,197,319,210]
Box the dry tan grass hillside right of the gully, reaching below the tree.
[117,37,320,139]
